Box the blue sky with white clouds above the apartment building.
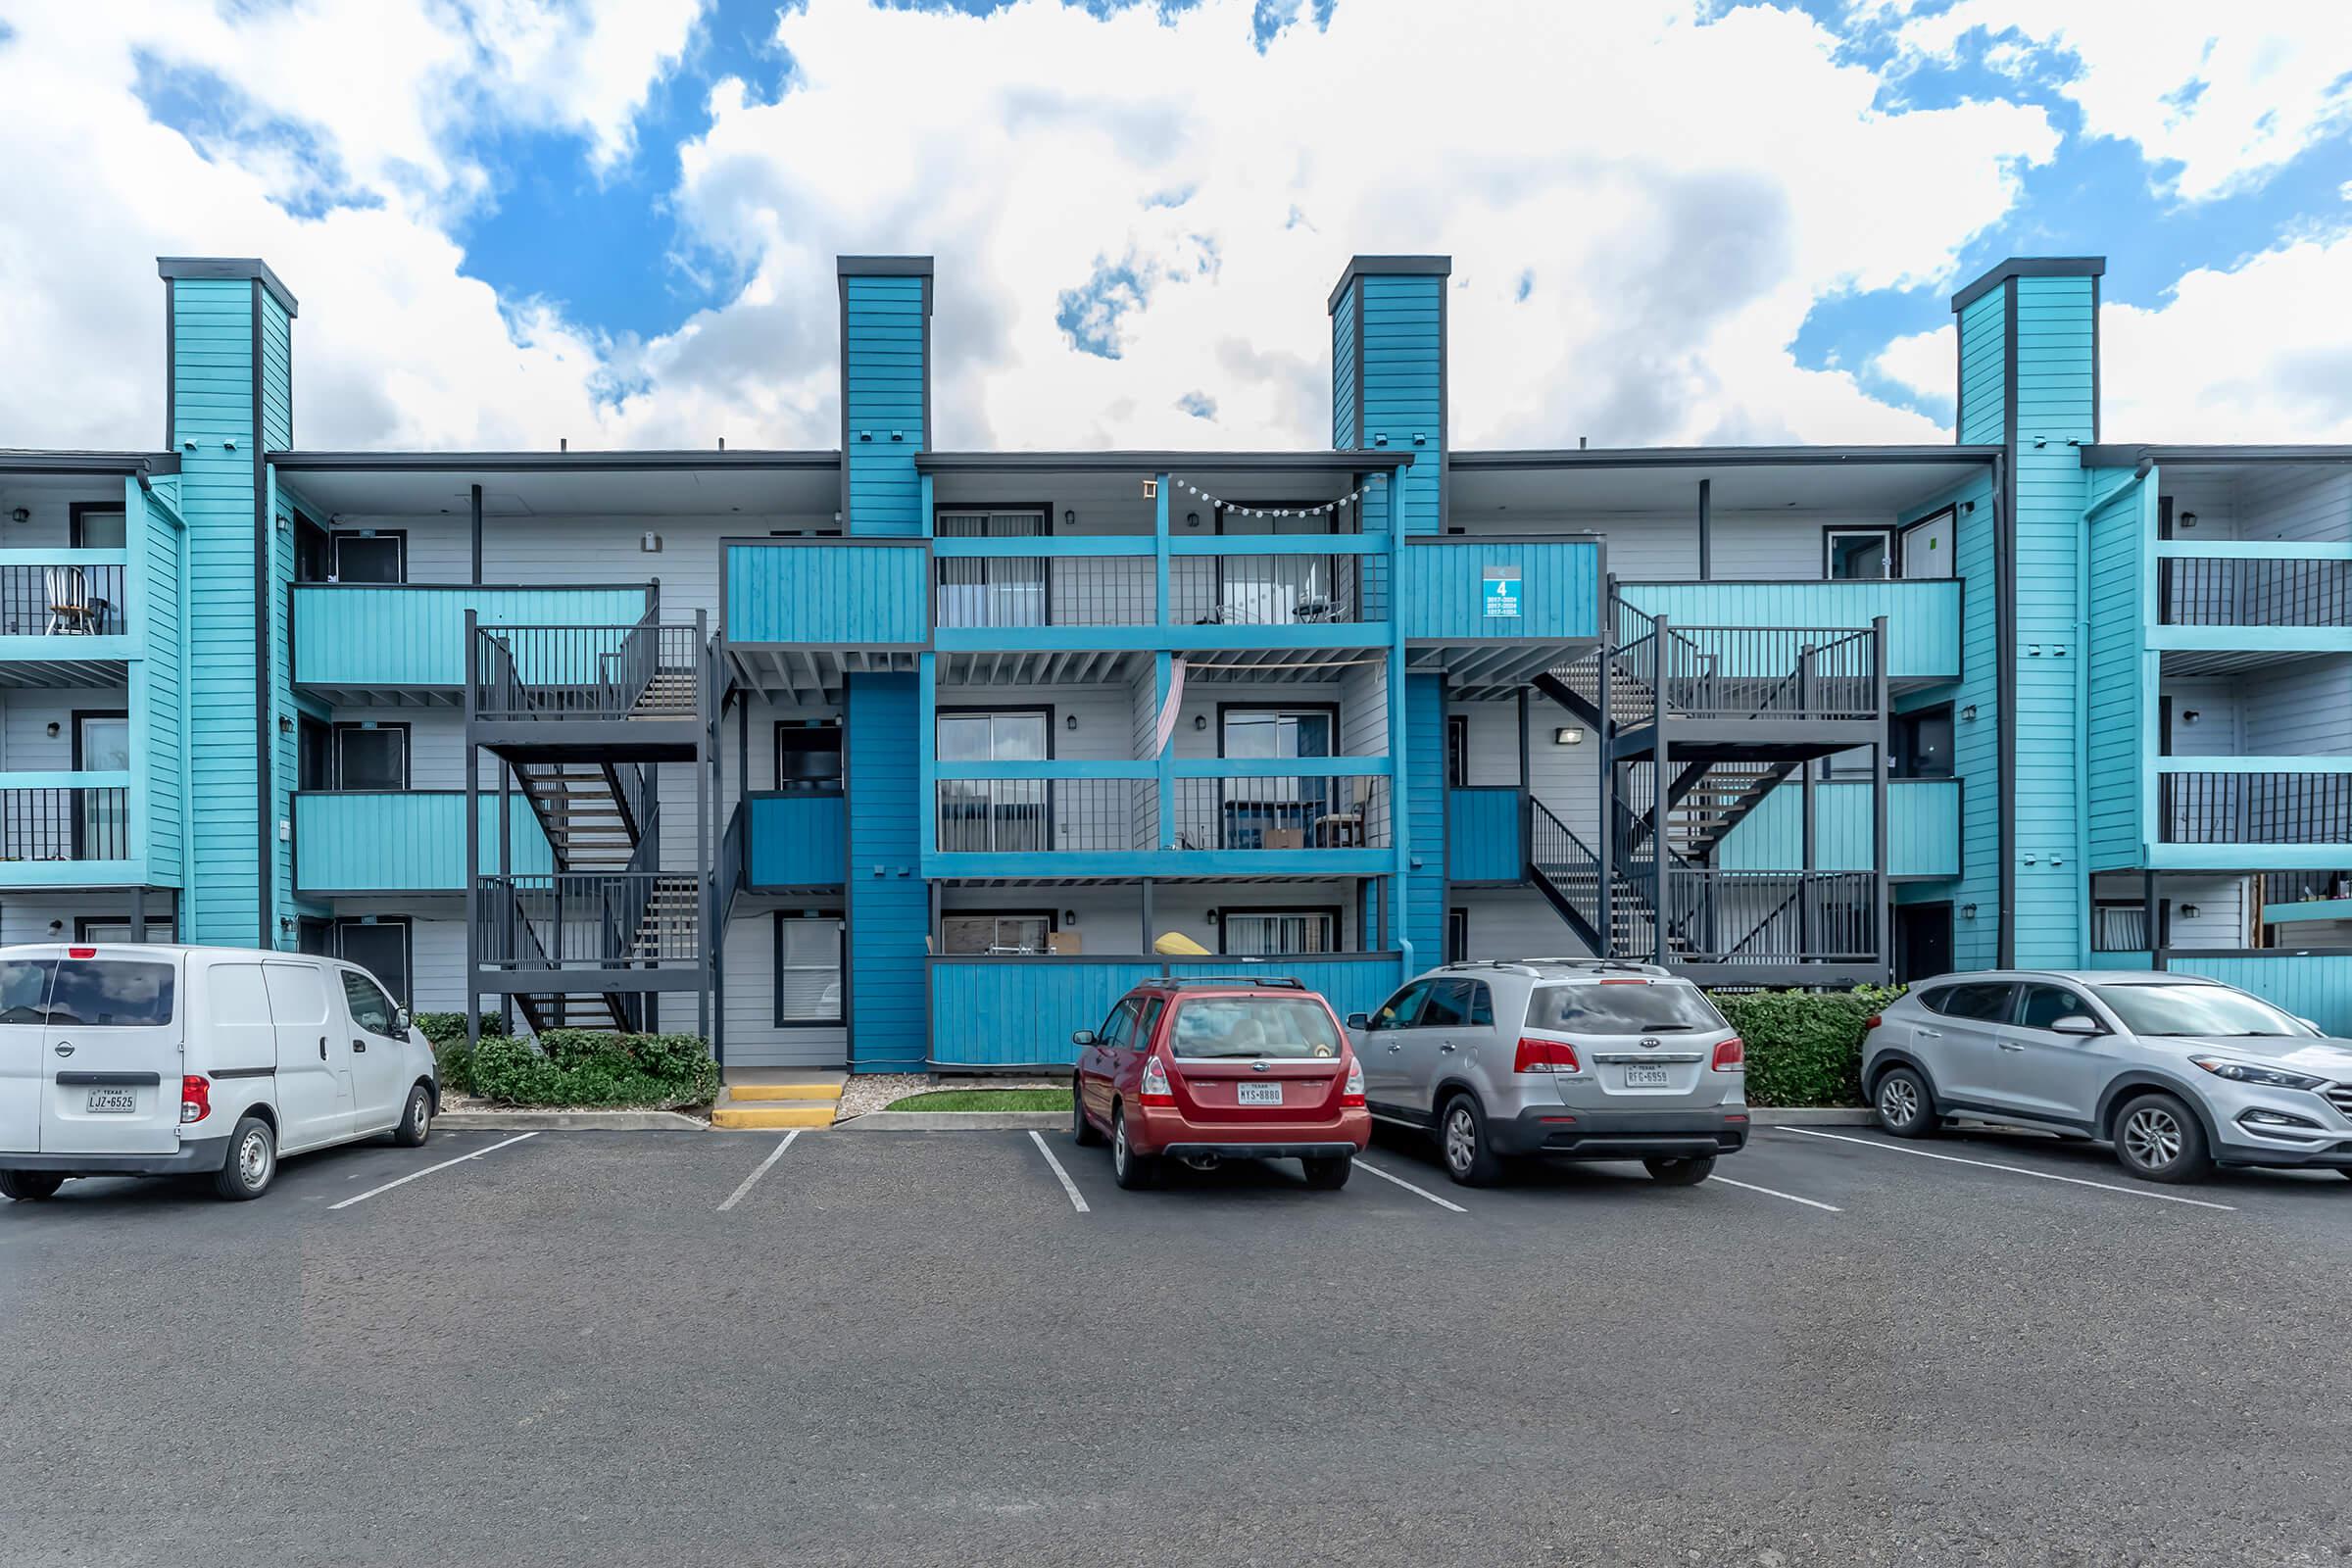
[0,0,2352,449]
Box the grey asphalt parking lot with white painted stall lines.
[0,1126,2352,1563]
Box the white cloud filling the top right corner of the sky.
[1898,0,2352,200]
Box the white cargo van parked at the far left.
[0,943,440,1201]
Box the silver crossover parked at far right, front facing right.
[1863,971,2352,1183]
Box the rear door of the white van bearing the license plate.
[40,948,181,1154]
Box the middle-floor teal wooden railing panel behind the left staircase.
[292,790,555,896]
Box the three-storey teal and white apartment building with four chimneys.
[0,256,2352,1069]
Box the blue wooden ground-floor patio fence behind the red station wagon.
[929,953,1401,1067]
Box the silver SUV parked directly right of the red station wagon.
[1348,959,1747,1187]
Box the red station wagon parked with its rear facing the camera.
[1070,976,1371,1190]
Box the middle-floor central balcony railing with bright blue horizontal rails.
[924,757,1395,879]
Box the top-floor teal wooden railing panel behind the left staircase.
[292,583,647,686]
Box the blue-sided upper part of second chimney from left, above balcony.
[842,277,931,534]
